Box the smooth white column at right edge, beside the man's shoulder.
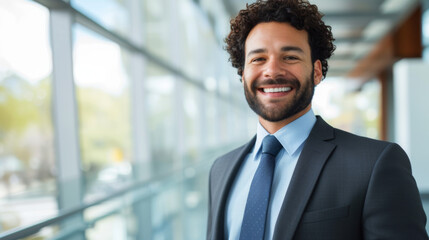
[393,59,429,192]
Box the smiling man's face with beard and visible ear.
[242,22,322,122]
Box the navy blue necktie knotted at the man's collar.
[240,135,282,240]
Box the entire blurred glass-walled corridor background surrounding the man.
[0,0,429,240]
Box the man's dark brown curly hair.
[225,0,335,78]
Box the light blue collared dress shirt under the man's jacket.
[225,110,316,240]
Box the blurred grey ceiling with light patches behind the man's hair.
[223,0,419,77]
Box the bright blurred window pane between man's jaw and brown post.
[313,78,381,138]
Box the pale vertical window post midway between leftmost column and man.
[128,0,153,239]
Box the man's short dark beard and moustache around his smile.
[243,69,315,122]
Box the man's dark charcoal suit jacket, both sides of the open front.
[207,117,428,240]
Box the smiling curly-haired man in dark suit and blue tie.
[207,0,428,240]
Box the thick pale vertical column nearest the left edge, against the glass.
[50,9,83,239]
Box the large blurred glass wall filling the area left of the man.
[0,0,252,240]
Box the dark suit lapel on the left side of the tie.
[212,136,256,239]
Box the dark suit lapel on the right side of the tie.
[273,117,336,240]
